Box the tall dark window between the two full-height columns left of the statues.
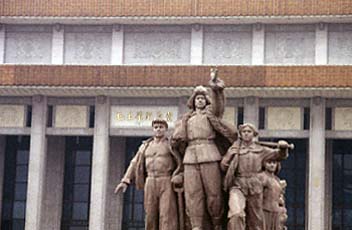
[61,137,93,230]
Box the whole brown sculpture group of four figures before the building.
[115,69,293,230]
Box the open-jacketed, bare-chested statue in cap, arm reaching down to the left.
[115,119,178,230]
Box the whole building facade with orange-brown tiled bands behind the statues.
[0,0,352,230]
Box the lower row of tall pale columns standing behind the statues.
[0,96,327,230]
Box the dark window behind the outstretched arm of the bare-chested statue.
[122,138,145,230]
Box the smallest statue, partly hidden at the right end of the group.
[259,159,287,230]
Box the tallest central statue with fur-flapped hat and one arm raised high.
[171,69,237,230]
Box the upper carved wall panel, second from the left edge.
[64,26,112,65]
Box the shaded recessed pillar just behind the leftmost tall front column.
[41,136,65,229]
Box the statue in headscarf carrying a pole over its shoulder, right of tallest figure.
[221,123,289,230]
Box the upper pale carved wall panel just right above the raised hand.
[203,26,252,64]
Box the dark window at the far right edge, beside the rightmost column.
[332,140,352,230]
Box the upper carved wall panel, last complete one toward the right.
[265,25,315,64]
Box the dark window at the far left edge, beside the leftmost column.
[1,136,29,230]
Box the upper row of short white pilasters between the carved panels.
[0,24,328,65]
